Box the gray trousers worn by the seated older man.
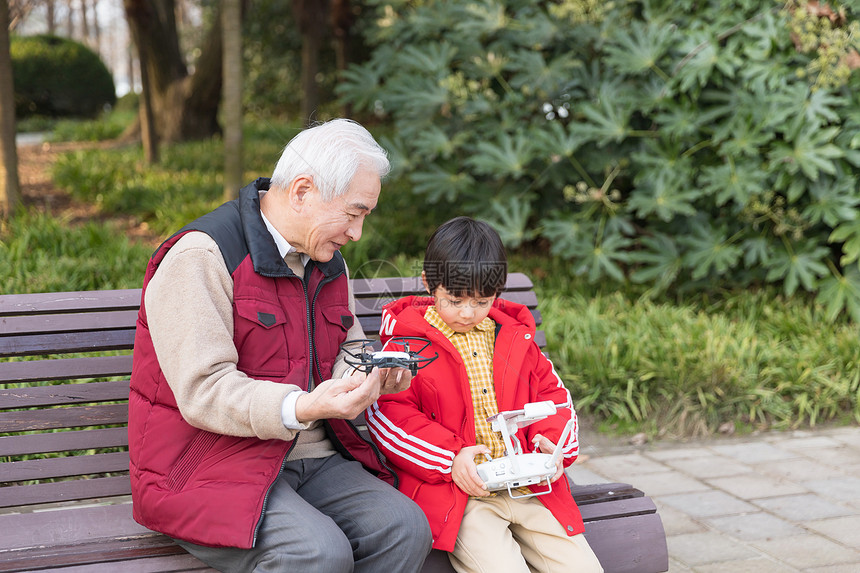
[176,454,432,573]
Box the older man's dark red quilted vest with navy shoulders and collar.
[128,179,391,548]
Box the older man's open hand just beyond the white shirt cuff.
[296,368,382,423]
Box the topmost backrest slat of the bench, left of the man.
[0,288,141,316]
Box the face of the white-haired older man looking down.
[293,170,381,263]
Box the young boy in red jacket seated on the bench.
[367,217,603,573]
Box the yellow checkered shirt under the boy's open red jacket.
[424,306,505,463]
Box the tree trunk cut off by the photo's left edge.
[0,2,21,219]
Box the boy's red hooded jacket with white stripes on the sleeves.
[367,297,584,551]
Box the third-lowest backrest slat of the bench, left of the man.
[0,426,128,456]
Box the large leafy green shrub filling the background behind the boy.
[339,0,860,321]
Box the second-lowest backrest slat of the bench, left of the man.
[3,452,128,482]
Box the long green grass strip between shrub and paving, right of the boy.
[540,274,860,436]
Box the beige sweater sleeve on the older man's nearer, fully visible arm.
[144,232,299,440]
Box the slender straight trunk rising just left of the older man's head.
[221,0,244,201]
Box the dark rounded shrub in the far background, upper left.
[10,35,116,117]
